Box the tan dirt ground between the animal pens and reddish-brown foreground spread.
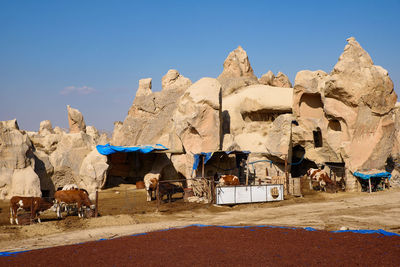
[0,185,400,254]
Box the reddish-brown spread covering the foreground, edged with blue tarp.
[0,226,400,266]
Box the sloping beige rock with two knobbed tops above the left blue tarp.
[111,70,191,150]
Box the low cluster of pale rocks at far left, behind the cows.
[0,108,108,199]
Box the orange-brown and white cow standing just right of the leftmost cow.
[54,189,93,218]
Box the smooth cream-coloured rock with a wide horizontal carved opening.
[222,84,293,152]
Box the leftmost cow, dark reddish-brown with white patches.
[10,196,53,224]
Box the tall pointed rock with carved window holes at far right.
[293,37,397,190]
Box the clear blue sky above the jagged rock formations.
[0,0,400,131]
